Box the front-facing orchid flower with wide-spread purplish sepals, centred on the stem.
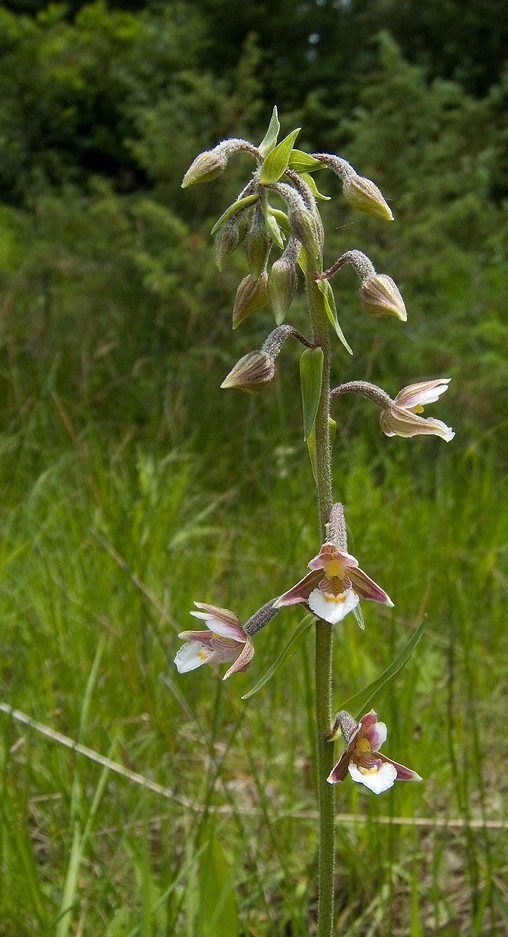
[274,543,393,625]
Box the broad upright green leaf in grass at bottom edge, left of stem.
[197,826,240,937]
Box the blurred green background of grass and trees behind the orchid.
[0,0,508,937]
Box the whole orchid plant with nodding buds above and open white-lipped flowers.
[175,108,454,937]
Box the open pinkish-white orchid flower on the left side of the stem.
[175,602,254,680]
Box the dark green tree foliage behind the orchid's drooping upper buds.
[0,0,508,454]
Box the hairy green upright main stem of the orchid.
[306,259,335,937]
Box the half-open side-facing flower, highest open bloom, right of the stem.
[381,378,455,442]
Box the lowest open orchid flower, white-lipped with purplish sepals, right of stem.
[327,709,422,794]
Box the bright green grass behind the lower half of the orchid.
[0,382,508,937]
